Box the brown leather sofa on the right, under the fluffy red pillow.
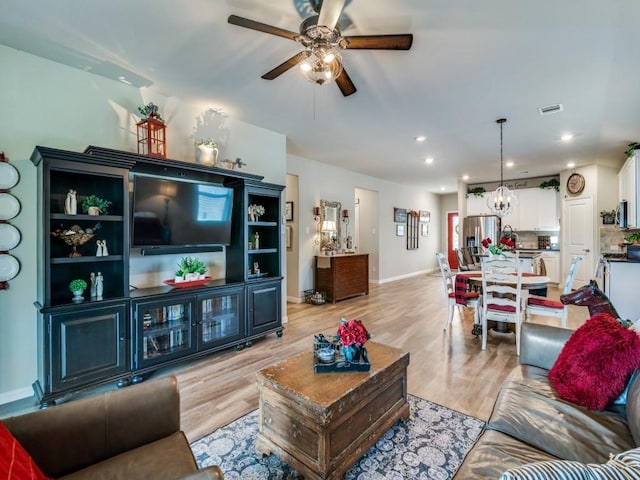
[454,322,640,480]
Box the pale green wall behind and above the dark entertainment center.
[0,46,286,404]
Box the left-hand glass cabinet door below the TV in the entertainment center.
[133,298,195,368]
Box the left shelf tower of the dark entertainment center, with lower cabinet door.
[31,146,133,406]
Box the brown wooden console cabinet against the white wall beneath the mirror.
[315,253,369,303]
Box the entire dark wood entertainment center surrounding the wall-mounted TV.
[31,146,284,407]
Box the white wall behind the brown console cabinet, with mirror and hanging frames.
[287,155,441,296]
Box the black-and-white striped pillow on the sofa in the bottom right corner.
[500,448,640,480]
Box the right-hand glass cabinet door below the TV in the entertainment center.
[198,287,244,350]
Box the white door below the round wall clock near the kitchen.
[562,197,593,288]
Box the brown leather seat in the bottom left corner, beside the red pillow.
[2,377,223,480]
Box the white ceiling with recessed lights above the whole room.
[0,0,640,193]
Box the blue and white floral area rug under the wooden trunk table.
[191,395,484,480]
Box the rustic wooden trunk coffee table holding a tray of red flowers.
[256,342,410,479]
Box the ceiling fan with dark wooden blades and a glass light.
[227,0,413,97]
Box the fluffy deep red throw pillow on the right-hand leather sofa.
[549,313,640,410]
